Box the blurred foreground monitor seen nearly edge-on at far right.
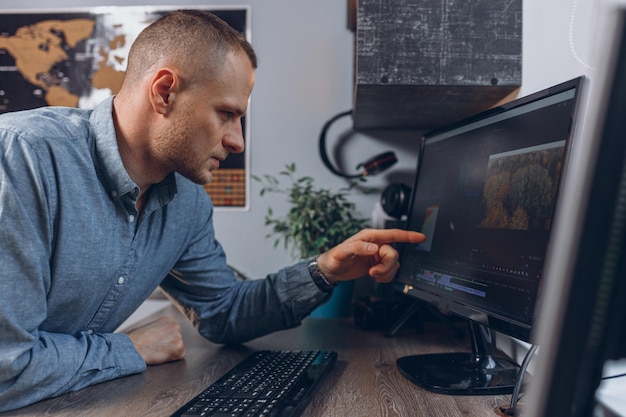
[523,10,626,417]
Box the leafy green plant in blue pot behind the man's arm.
[252,163,367,317]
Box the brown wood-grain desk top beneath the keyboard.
[0,307,510,417]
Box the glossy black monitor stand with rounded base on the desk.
[396,320,519,395]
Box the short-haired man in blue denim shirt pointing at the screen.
[0,11,423,411]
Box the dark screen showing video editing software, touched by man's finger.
[403,91,574,326]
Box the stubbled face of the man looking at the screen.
[155,52,254,184]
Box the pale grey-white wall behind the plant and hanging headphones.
[0,0,616,277]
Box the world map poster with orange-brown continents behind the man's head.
[0,6,250,208]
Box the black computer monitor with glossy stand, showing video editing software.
[395,77,582,395]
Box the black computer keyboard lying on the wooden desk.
[172,350,337,417]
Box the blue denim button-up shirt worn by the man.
[0,99,326,411]
